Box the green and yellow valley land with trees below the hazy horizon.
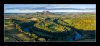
[4,13,96,42]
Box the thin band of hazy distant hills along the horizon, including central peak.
[4,11,96,15]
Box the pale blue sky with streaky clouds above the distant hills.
[4,4,96,13]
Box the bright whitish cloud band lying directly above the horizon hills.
[4,10,96,13]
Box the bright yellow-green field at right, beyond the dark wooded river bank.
[63,15,96,30]
